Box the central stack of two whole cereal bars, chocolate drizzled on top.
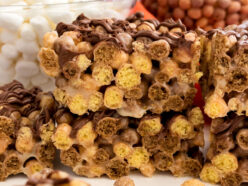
[39,13,204,179]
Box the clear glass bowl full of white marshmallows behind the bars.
[0,0,136,90]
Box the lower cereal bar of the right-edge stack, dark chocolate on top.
[200,112,248,186]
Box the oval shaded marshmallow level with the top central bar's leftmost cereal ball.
[15,59,40,78]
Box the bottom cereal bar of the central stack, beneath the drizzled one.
[52,107,204,179]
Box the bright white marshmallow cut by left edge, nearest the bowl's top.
[0,13,23,31]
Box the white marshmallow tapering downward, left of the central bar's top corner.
[30,16,51,40]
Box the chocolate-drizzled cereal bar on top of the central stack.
[39,13,202,118]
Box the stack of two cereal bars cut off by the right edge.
[201,23,248,186]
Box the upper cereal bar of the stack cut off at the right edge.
[202,22,248,119]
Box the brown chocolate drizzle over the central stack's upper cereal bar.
[55,13,191,66]
